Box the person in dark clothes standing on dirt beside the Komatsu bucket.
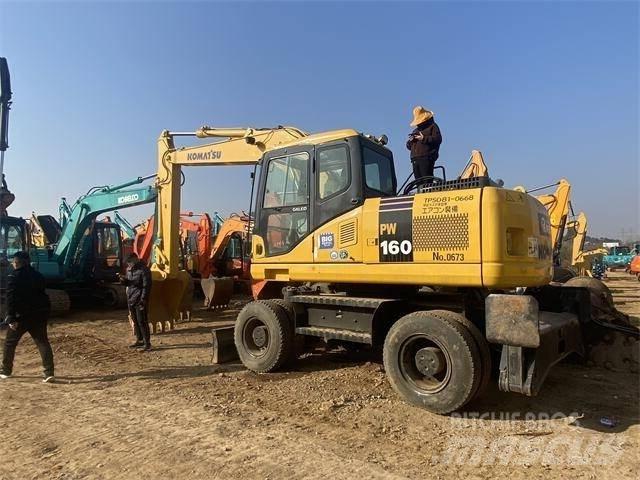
[120,253,151,351]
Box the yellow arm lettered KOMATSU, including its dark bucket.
[150,126,307,325]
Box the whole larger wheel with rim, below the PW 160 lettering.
[383,311,482,413]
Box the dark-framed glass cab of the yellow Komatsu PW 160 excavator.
[255,132,397,257]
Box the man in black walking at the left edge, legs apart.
[0,252,53,383]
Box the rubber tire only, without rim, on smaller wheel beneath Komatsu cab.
[234,300,293,373]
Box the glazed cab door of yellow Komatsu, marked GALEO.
[257,146,314,257]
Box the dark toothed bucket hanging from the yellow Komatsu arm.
[149,271,193,333]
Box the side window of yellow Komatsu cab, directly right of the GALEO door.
[316,145,351,200]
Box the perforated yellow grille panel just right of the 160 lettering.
[413,213,469,251]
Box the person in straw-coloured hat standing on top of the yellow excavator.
[407,106,442,184]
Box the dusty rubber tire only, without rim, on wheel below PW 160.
[383,311,482,414]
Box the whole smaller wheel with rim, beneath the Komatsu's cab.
[234,300,293,373]
